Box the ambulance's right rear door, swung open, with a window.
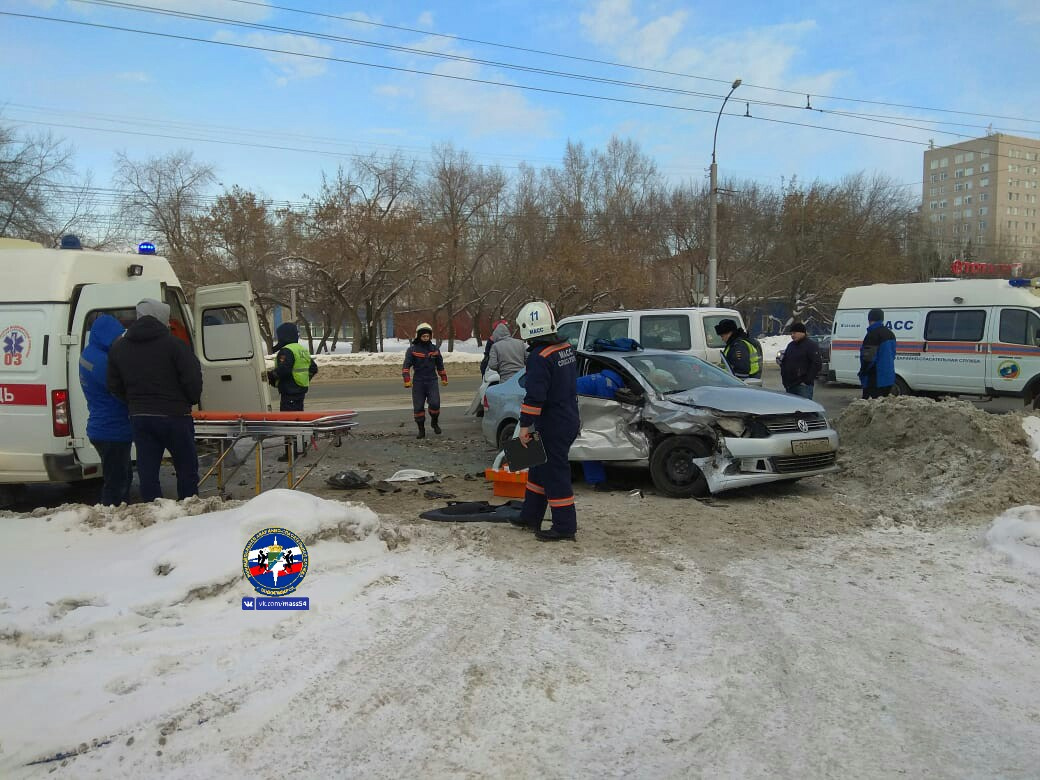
[194,282,270,412]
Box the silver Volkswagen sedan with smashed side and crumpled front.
[484,349,838,498]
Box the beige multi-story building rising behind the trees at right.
[921,133,1040,265]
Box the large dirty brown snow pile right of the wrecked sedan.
[833,397,1040,525]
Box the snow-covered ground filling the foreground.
[6,491,1040,778]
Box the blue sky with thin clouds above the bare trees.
[0,0,1040,202]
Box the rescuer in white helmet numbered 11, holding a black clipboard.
[517,301,581,542]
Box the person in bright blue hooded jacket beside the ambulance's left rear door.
[79,314,133,506]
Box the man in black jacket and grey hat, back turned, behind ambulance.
[108,298,202,501]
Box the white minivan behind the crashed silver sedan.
[556,307,744,363]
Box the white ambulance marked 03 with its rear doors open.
[0,236,271,505]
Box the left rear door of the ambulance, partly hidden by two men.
[64,279,165,465]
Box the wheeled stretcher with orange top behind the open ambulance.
[191,411,358,495]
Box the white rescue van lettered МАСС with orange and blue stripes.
[831,279,1040,407]
